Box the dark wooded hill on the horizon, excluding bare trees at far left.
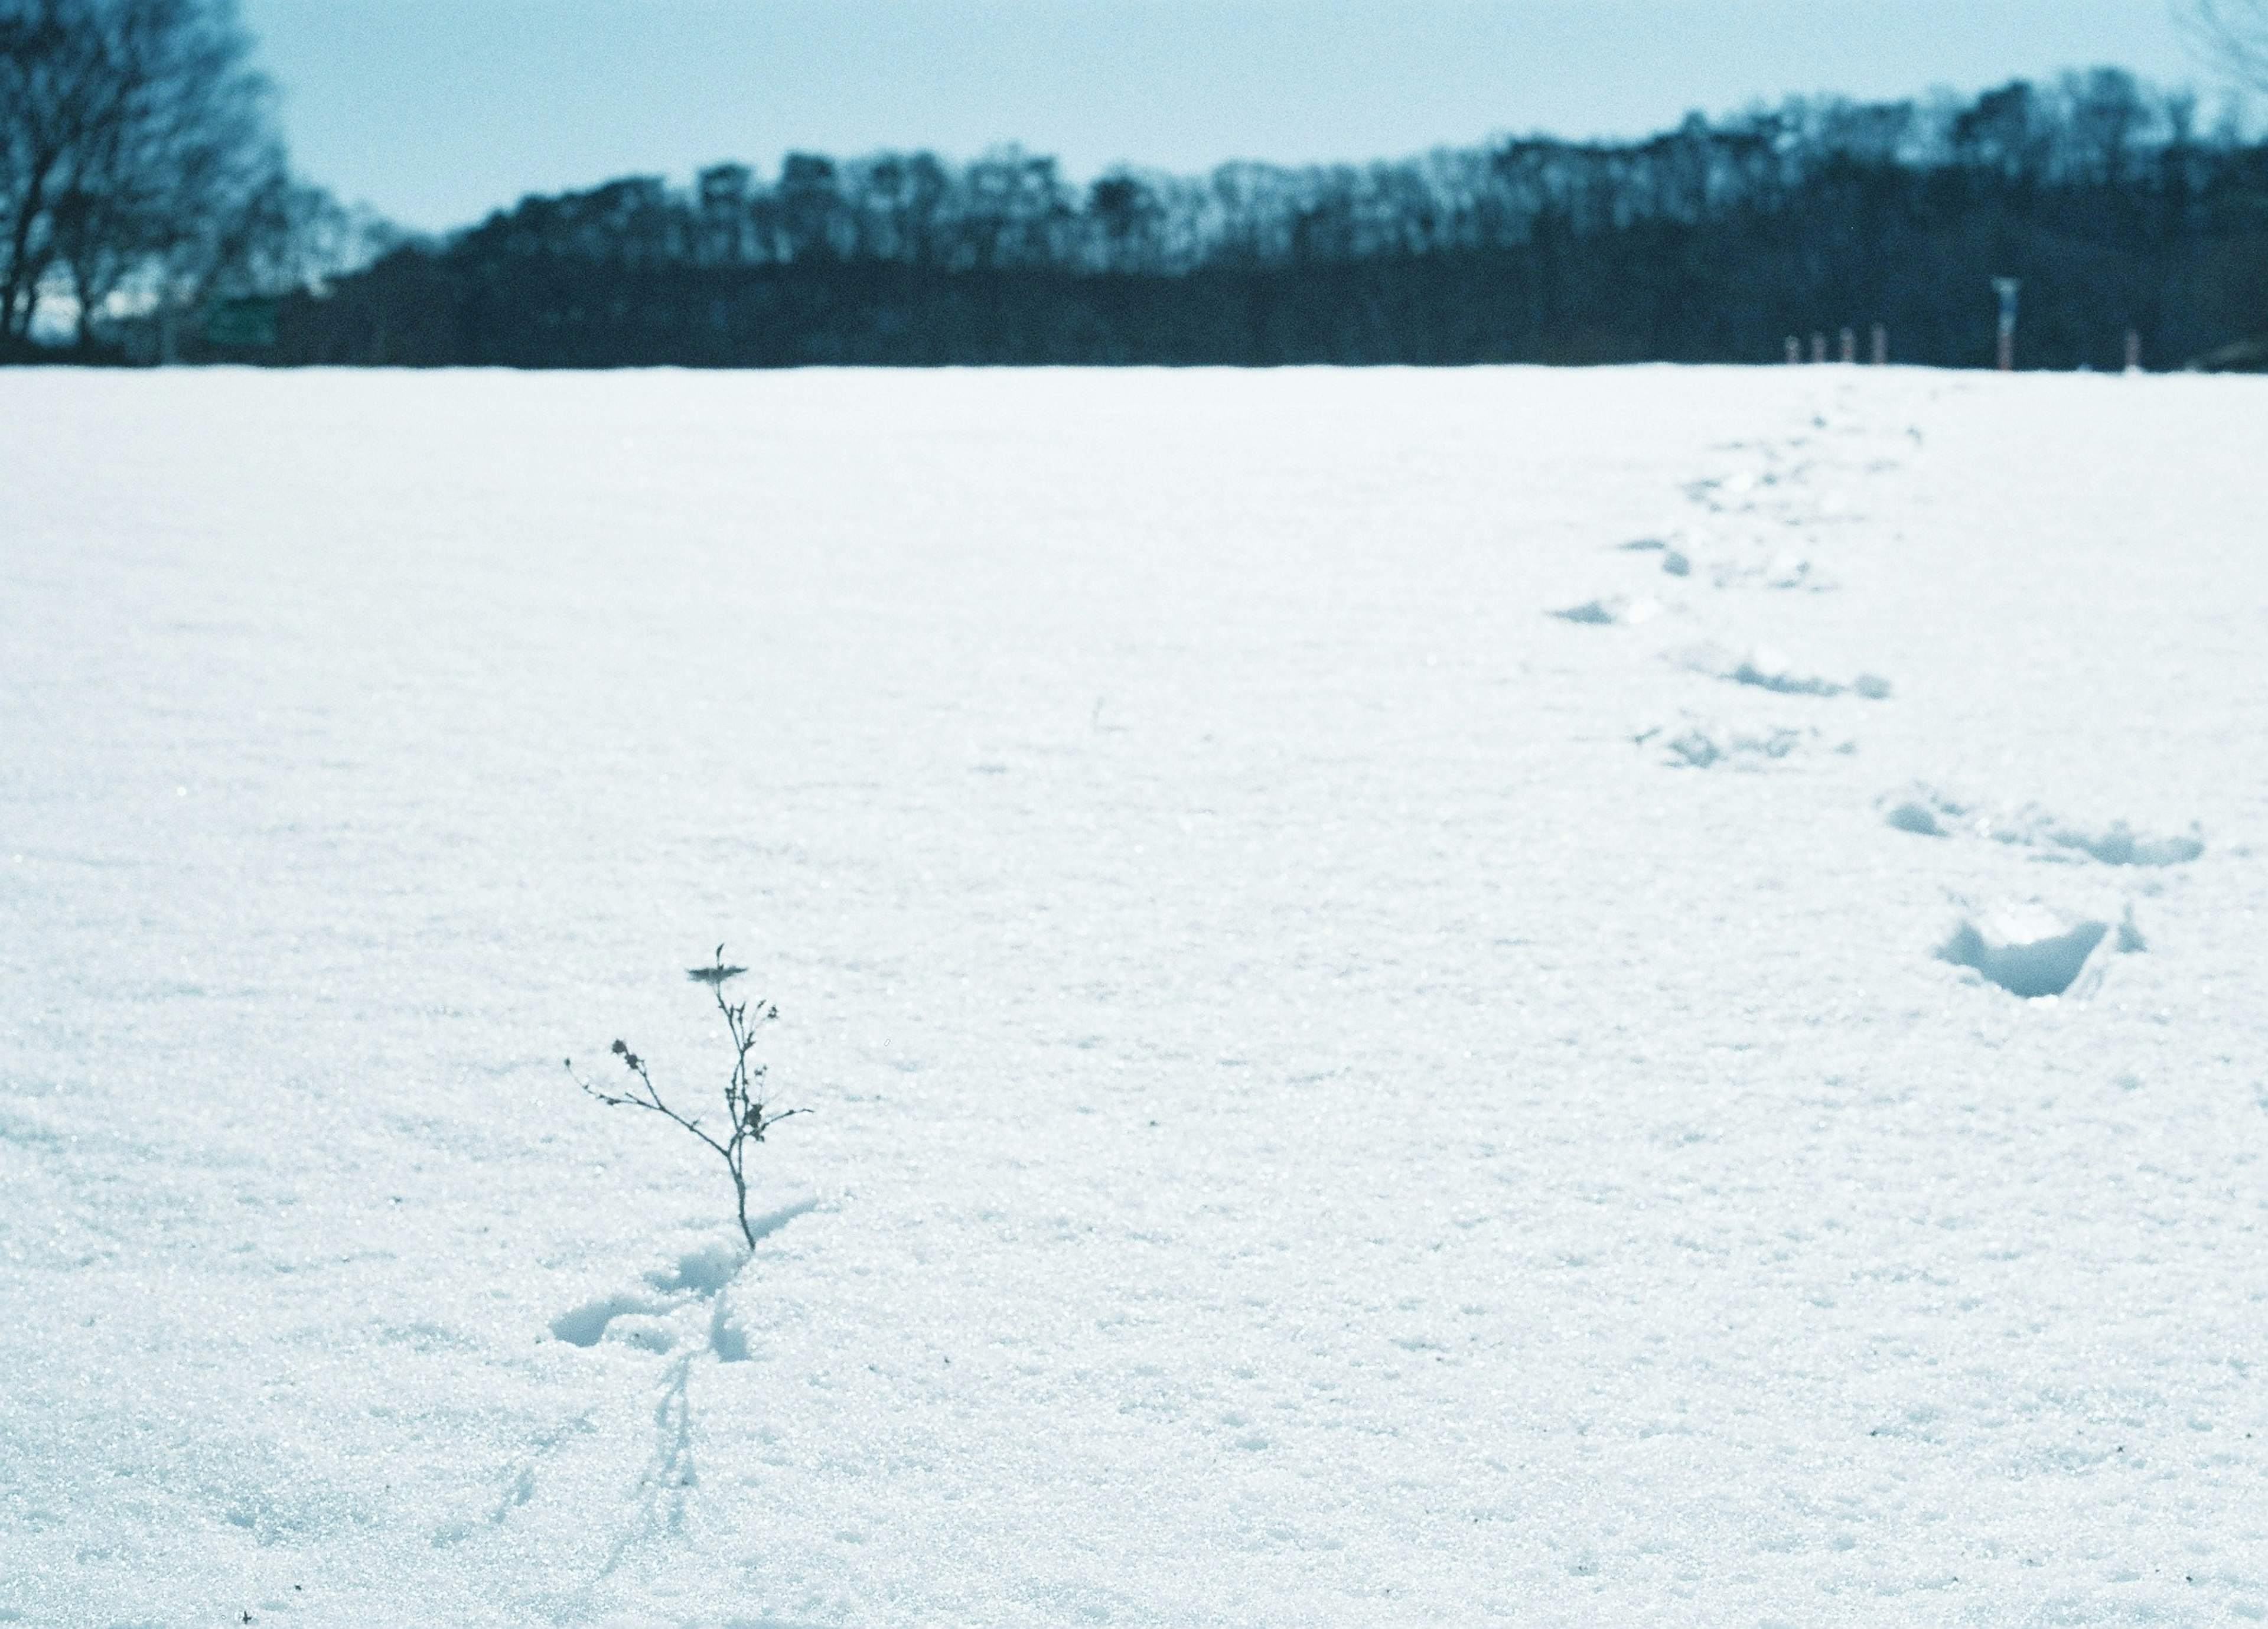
[275,68,2268,367]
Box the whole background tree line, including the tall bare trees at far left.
[0,0,2268,367]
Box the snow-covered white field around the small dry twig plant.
[0,367,2268,1627]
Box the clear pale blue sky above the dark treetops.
[240,0,2218,229]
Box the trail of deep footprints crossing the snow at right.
[1552,399,2204,1001]
